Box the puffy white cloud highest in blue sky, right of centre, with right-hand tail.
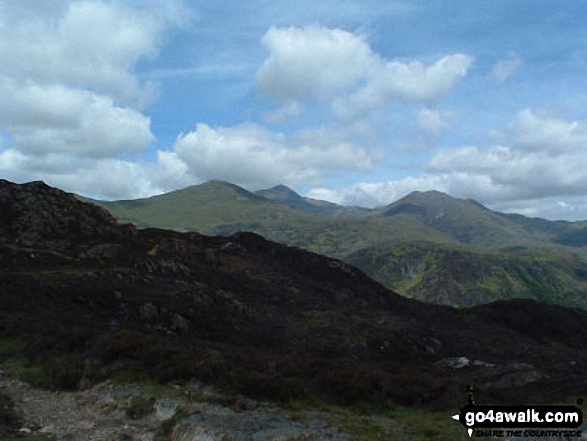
[257,26,473,119]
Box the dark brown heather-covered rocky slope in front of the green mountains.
[0,181,587,406]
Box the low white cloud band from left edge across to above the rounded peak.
[0,118,380,199]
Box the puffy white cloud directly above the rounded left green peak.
[174,124,377,188]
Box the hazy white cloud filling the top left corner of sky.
[0,1,186,103]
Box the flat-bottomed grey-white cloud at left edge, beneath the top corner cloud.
[0,78,154,157]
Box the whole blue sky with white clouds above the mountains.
[0,0,587,220]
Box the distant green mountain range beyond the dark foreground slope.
[85,181,587,308]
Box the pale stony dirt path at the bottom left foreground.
[0,371,349,441]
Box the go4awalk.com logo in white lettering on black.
[452,402,583,438]
